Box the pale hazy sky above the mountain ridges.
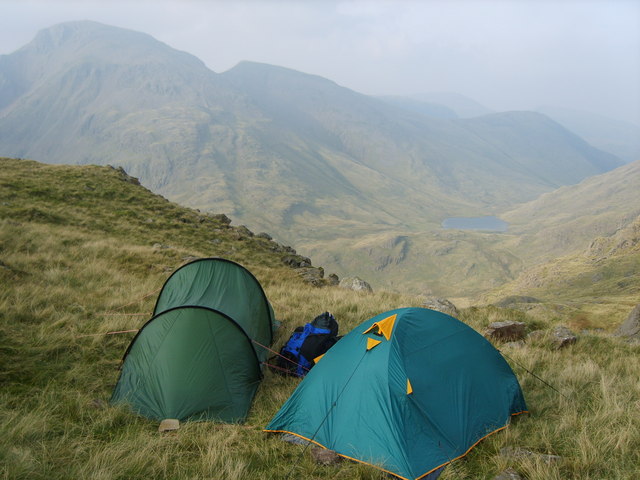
[0,0,640,125]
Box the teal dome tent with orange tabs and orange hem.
[265,308,526,480]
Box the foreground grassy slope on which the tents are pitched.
[0,159,640,480]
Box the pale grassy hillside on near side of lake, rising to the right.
[304,162,640,303]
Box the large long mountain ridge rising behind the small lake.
[0,22,622,296]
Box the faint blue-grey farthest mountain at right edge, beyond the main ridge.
[537,107,640,162]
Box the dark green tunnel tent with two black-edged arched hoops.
[111,258,275,422]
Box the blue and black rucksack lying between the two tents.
[276,312,339,377]
